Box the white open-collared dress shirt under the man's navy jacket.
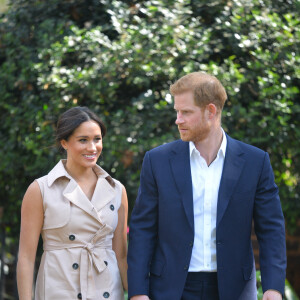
[189,129,227,272]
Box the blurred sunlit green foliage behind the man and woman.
[0,0,300,298]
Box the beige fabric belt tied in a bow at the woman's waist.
[43,232,112,300]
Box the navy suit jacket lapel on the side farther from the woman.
[217,135,245,226]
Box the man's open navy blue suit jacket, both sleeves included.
[128,136,286,300]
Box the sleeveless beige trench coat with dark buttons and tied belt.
[35,160,124,300]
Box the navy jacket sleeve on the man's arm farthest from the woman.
[253,153,286,294]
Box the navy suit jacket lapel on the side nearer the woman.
[170,141,194,230]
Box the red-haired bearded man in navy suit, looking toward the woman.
[128,72,286,300]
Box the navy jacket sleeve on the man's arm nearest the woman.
[128,152,158,299]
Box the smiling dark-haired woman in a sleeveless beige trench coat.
[17,107,128,300]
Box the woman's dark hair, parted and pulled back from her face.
[56,106,106,150]
